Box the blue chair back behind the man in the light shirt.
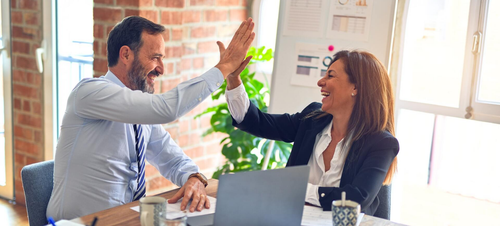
[21,160,54,226]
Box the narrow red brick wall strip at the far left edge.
[11,0,44,204]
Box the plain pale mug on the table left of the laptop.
[139,197,167,226]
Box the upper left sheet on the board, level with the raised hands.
[283,0,328,38]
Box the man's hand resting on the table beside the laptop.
[168,177,210,212]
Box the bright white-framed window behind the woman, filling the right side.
[392,0,500,225]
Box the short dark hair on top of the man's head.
[107,16,165,67]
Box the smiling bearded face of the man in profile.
[127,32,165,94]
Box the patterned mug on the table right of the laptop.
[332,200,361,226]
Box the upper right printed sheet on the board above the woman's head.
[326,0,374,41]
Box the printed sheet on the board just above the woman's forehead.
[290,43,334,87]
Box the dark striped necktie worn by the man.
[134,124,146,201]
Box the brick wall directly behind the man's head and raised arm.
[94,0,247,195]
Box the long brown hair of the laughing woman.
[316,50,397,185]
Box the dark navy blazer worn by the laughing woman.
[233,102,399,215]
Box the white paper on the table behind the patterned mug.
[301,206,365,226]
